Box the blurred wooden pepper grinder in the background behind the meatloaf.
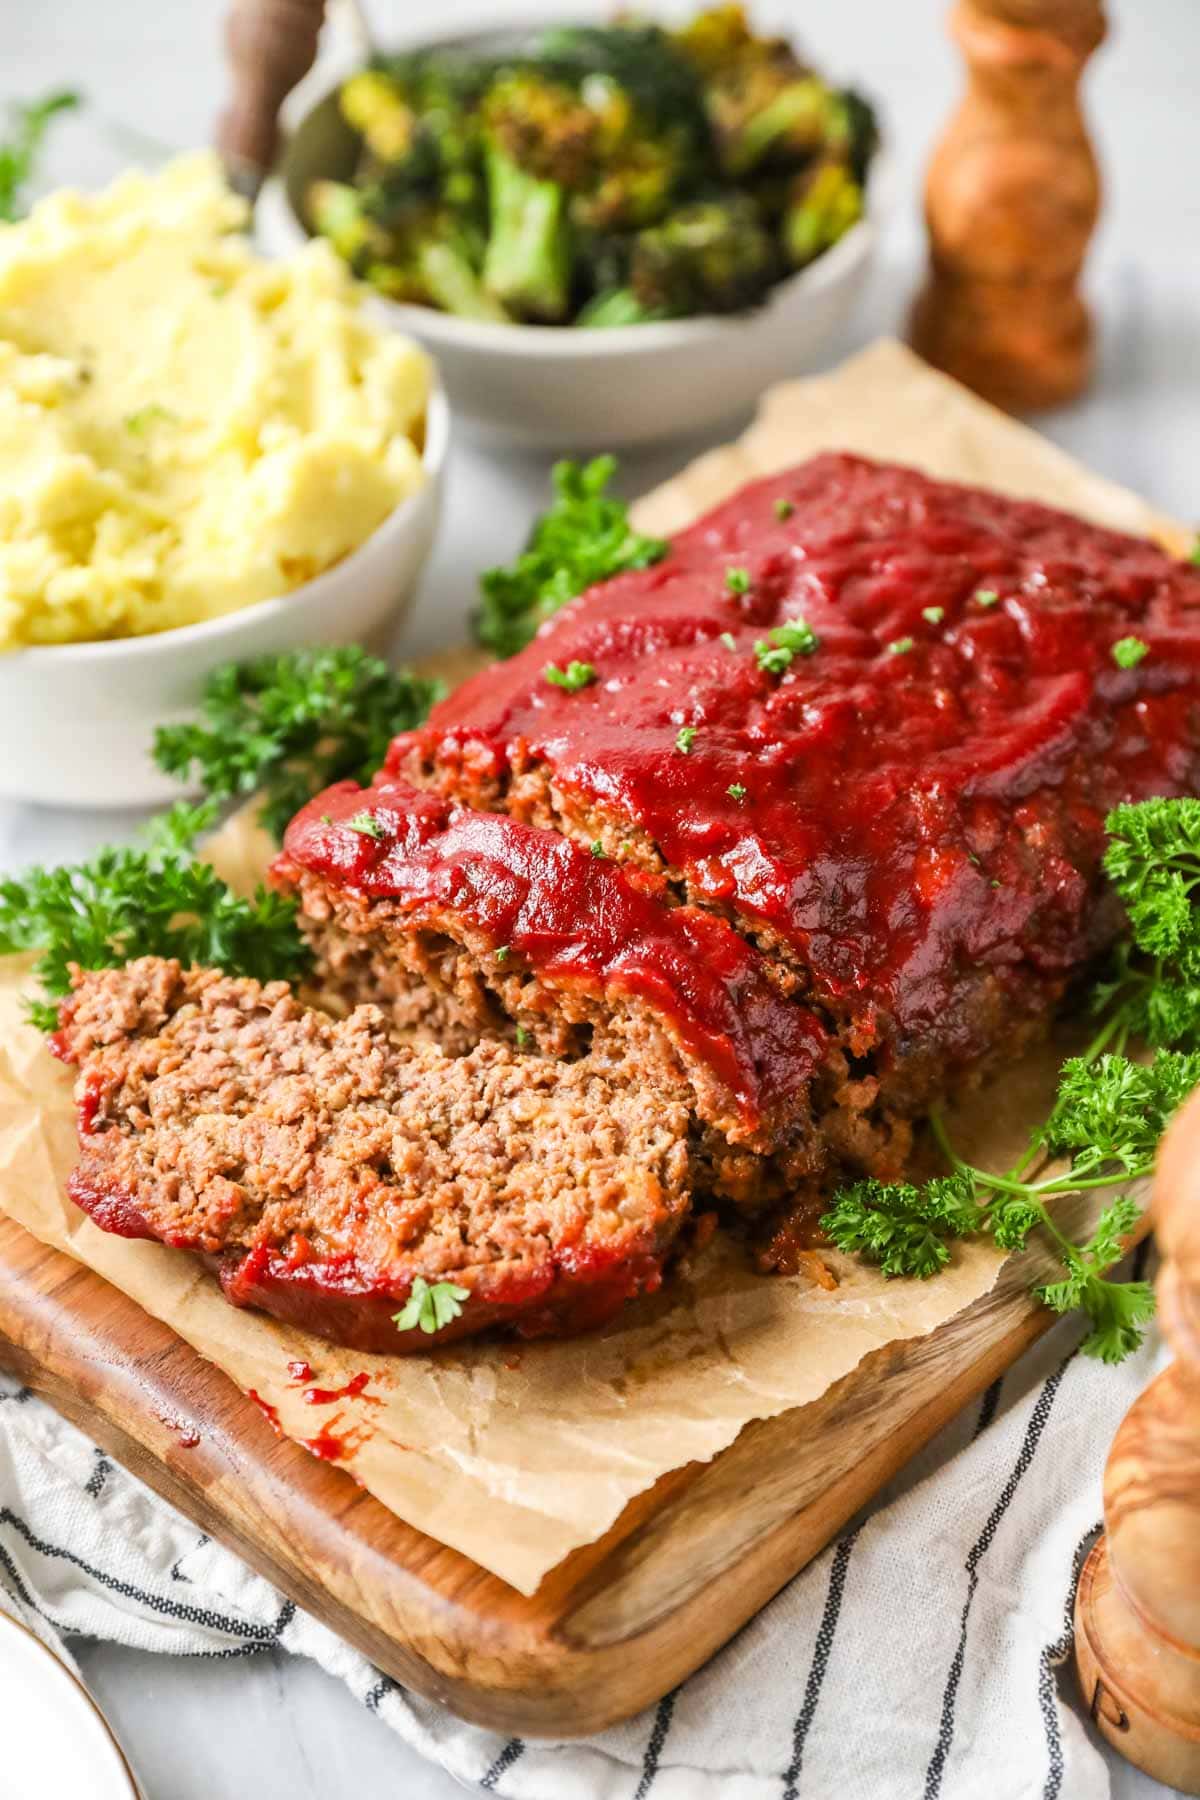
[910,0,1105,412]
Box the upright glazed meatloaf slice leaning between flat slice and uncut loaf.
[273,779,864,1208]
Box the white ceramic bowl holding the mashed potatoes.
[0,389,450,806]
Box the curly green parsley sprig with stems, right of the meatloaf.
[820,799,1200,1363]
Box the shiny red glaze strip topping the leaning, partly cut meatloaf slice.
[277,776,826,1125]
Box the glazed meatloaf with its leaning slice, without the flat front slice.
[275,455,1200,1211]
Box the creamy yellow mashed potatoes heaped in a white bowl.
[0,157,430,650]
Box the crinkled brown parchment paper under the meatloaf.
[0,344,1186,1593]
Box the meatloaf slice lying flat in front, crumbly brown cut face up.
[56,958,689,1352]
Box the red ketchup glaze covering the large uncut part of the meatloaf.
[385,455,1200,1030]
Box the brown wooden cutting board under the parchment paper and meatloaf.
[0,1202,1094,1737]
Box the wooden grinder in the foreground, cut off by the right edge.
[1076,1098,1200,1795]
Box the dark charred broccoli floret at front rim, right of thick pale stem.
[630,193,781,315]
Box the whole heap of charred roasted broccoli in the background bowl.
[308,5,876,328]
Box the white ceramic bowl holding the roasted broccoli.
[257,40,887,450]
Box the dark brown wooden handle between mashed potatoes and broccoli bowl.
[216,0,326,194]
